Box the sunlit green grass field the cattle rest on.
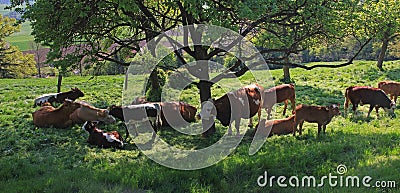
[0,61,400,193]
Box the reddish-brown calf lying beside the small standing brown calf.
[254,115,294,136]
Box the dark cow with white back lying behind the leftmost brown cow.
[34,87,84,107]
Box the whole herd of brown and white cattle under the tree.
[32,81,400,148]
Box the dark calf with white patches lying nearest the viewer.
[82,121,124,149]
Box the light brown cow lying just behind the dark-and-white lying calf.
[70,101,115,124]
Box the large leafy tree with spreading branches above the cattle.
[13,0,370,136]
